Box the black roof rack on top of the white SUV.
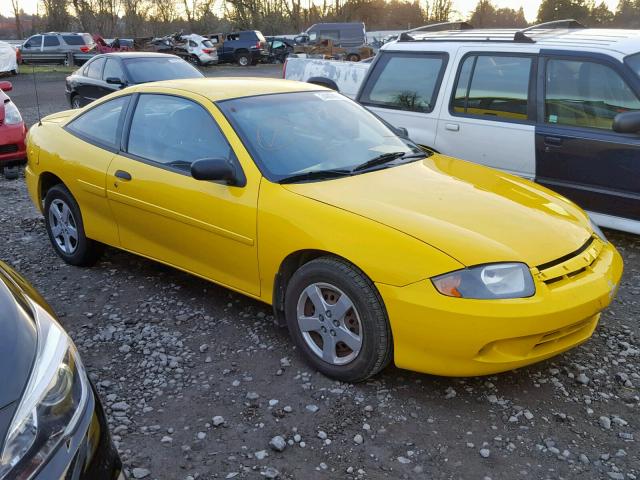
[398,19,586,43]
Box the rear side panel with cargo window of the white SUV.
[357,51,448,148]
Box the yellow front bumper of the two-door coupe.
[377,239,623,376]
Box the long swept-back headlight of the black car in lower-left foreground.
[0,303,88,480]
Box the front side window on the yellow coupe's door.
[127,94,231,172]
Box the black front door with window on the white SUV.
[536,51,640,227]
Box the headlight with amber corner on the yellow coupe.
[431,263,536,300]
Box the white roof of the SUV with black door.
[383,28,640,55]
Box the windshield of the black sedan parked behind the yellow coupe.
[124,57,203,83]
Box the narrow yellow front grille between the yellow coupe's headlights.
[536,236,604,286]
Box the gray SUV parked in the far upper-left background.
[20,32,96,63]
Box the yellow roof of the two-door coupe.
[134,77,328,102]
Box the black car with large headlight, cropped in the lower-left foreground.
[0,262,125,480]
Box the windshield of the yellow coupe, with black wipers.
[218,91,426,182]
